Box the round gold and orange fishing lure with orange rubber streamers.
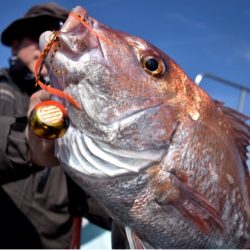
[29,12,115,139]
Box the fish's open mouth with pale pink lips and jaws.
[39,6,103,85]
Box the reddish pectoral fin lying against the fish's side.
[156,173,224,233]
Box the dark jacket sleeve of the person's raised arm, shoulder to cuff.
[0,71,42,185]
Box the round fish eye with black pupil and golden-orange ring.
[141,54,165,76]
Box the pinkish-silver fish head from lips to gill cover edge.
[40,7,207,150]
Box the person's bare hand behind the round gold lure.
[26,90,59,167]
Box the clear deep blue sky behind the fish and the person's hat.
[0,0,250,115]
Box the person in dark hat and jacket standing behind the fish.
[0,3,114,249]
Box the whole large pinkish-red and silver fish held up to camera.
[40,7,250,248]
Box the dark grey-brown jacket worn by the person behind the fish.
[0,61,111,249]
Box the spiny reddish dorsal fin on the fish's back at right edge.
[215,101,250,195]
